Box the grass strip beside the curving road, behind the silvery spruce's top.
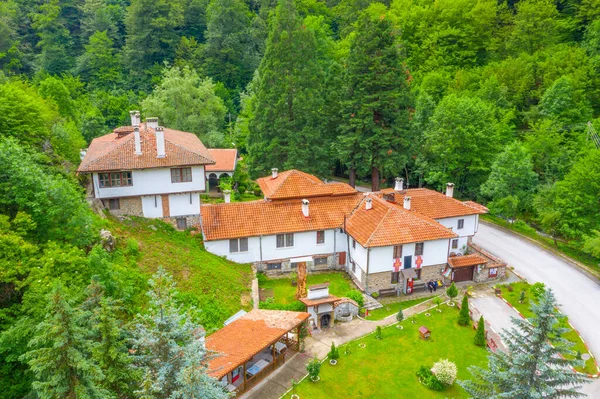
[498,282,598,374]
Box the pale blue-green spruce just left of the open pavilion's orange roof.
[132,267,228,399]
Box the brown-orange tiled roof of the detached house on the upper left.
[78,123,214,172]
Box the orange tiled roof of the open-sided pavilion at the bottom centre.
[206,309,309,379]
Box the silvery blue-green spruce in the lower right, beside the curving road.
[460,290,589,399]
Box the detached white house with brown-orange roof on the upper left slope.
[78,111,215,229]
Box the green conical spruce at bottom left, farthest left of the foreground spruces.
[22,283,110,399]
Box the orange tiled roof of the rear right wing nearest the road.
[378,188,487,219]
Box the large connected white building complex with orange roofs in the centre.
[201,169,503,293]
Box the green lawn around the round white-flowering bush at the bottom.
[286,305,488,399]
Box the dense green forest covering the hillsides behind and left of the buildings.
[0,0,600,398]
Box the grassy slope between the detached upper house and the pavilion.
[110,217,252,331]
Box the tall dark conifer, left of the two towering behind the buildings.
[248,0,332,176]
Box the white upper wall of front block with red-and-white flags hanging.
[369,239,452,273]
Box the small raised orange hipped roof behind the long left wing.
[256,169,356,200]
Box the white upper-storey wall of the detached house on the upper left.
[93,166,206,198]
